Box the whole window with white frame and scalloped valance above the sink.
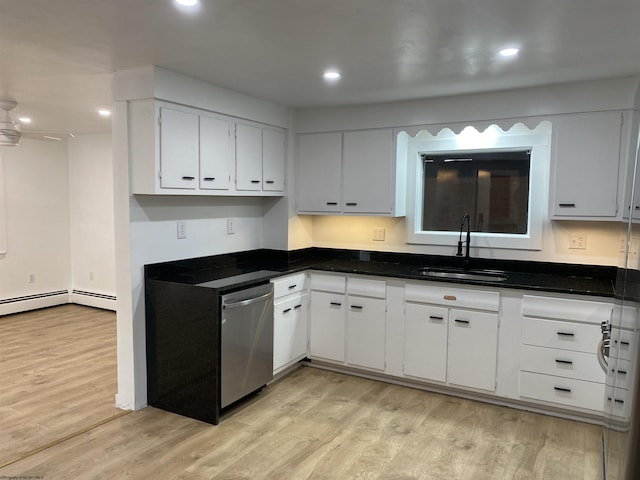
[398,122,551,250]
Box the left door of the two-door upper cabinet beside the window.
[298,133,342,213]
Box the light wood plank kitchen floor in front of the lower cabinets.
[0,306,601,480]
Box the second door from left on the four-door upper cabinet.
[200,115,233,190]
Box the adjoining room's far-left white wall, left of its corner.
[0,139,71,315]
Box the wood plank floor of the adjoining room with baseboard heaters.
[0,305,121,465]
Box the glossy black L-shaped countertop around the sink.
[145,248,619,297]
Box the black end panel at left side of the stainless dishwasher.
[145,279,220,424]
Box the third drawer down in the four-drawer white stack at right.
[520,345,605,383]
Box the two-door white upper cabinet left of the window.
[298,129,405,216]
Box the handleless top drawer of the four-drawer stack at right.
[522,295,613,325]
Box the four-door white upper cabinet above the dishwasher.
[129,99,286,196]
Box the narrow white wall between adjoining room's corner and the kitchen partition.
[69,133,116,310]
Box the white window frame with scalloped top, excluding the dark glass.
[404,121,551,250]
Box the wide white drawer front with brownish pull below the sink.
[404,283,500,312]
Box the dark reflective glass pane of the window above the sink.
[421,149,531,235]
